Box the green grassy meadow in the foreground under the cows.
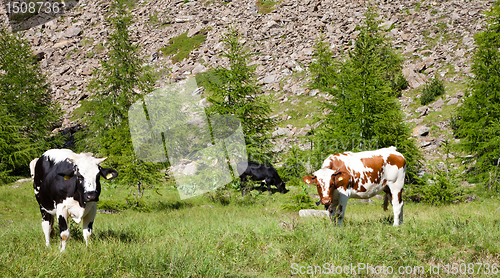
[0,182,500,277]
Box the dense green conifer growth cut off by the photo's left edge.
[0,26,61,183]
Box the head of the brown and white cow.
[302,168,350,205]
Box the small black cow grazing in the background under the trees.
[237,161,287,195]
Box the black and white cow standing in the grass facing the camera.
[33,149,118,252]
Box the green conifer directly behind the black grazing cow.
[207,28,273,161]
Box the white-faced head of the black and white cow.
[59,153,118,203]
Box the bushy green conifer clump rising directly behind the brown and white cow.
[310,8,420,178]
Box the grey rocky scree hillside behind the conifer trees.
[0,0,493,166]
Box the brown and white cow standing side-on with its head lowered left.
[302,147,406,226]
